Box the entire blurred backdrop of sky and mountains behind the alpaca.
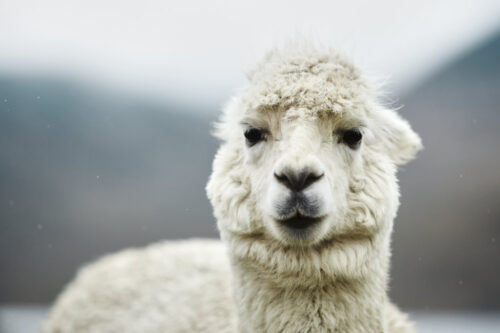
[0,0,500,333]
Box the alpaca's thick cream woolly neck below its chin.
[225,233,387,333]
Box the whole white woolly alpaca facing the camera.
[42,47,421,333]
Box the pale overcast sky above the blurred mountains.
[0,0,500,106]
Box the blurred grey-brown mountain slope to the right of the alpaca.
[392,35,500,310]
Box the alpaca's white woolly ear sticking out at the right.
[376,109,422,165]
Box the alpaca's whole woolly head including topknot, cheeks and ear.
[207,44,421,252]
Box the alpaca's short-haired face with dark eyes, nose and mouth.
[241,110,356,245]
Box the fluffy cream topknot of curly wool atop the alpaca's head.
[243,44,370,113]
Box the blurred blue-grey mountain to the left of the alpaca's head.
[0,77,217,302]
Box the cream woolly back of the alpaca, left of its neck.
[42,239,233,333]
